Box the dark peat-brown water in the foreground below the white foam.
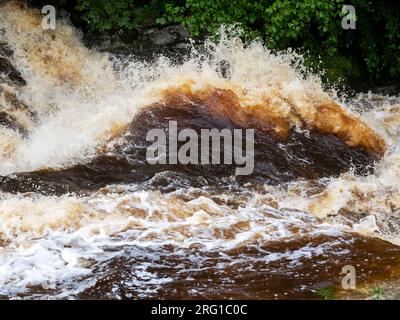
[3,235,400,299]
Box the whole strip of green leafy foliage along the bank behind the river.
[42,0,400,82]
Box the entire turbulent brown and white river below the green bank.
[0,2,400,299]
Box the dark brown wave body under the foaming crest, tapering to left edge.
[0,92,378,194]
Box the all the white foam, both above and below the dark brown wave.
[0,4,400,295]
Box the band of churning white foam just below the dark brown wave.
[0,187,343,294]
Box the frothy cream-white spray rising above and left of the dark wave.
[0,2,334,175]
